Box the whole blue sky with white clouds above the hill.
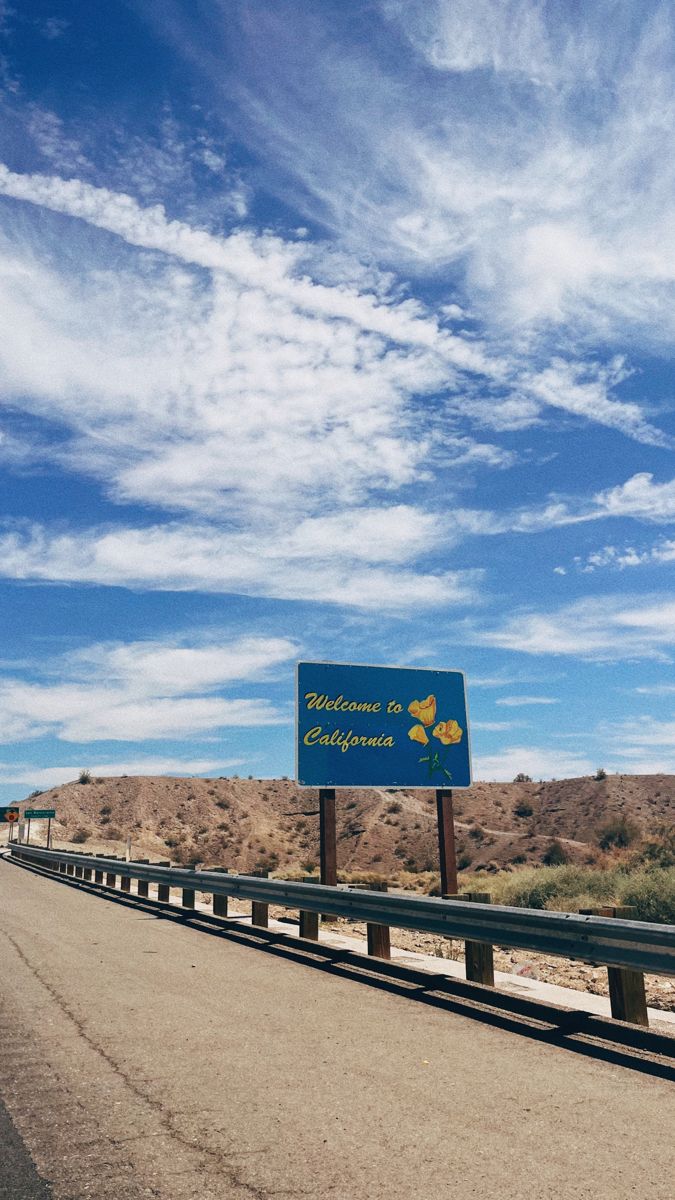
[0,0,675,799]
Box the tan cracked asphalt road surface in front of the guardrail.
[0,859,675,1200]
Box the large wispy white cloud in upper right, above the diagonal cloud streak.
[196,0,675,360]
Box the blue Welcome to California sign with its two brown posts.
[295,662,471,894]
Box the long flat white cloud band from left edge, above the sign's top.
[0,518,482,612]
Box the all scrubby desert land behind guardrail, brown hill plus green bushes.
[6,769,675,920]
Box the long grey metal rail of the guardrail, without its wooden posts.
[10,845,675,976]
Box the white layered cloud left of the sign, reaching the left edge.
[0,636,297,742]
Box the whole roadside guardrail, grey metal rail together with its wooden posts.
[10,844,675,1025]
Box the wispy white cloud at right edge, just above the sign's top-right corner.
[472,596,675,661]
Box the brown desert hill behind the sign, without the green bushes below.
[2,774,675,875]
